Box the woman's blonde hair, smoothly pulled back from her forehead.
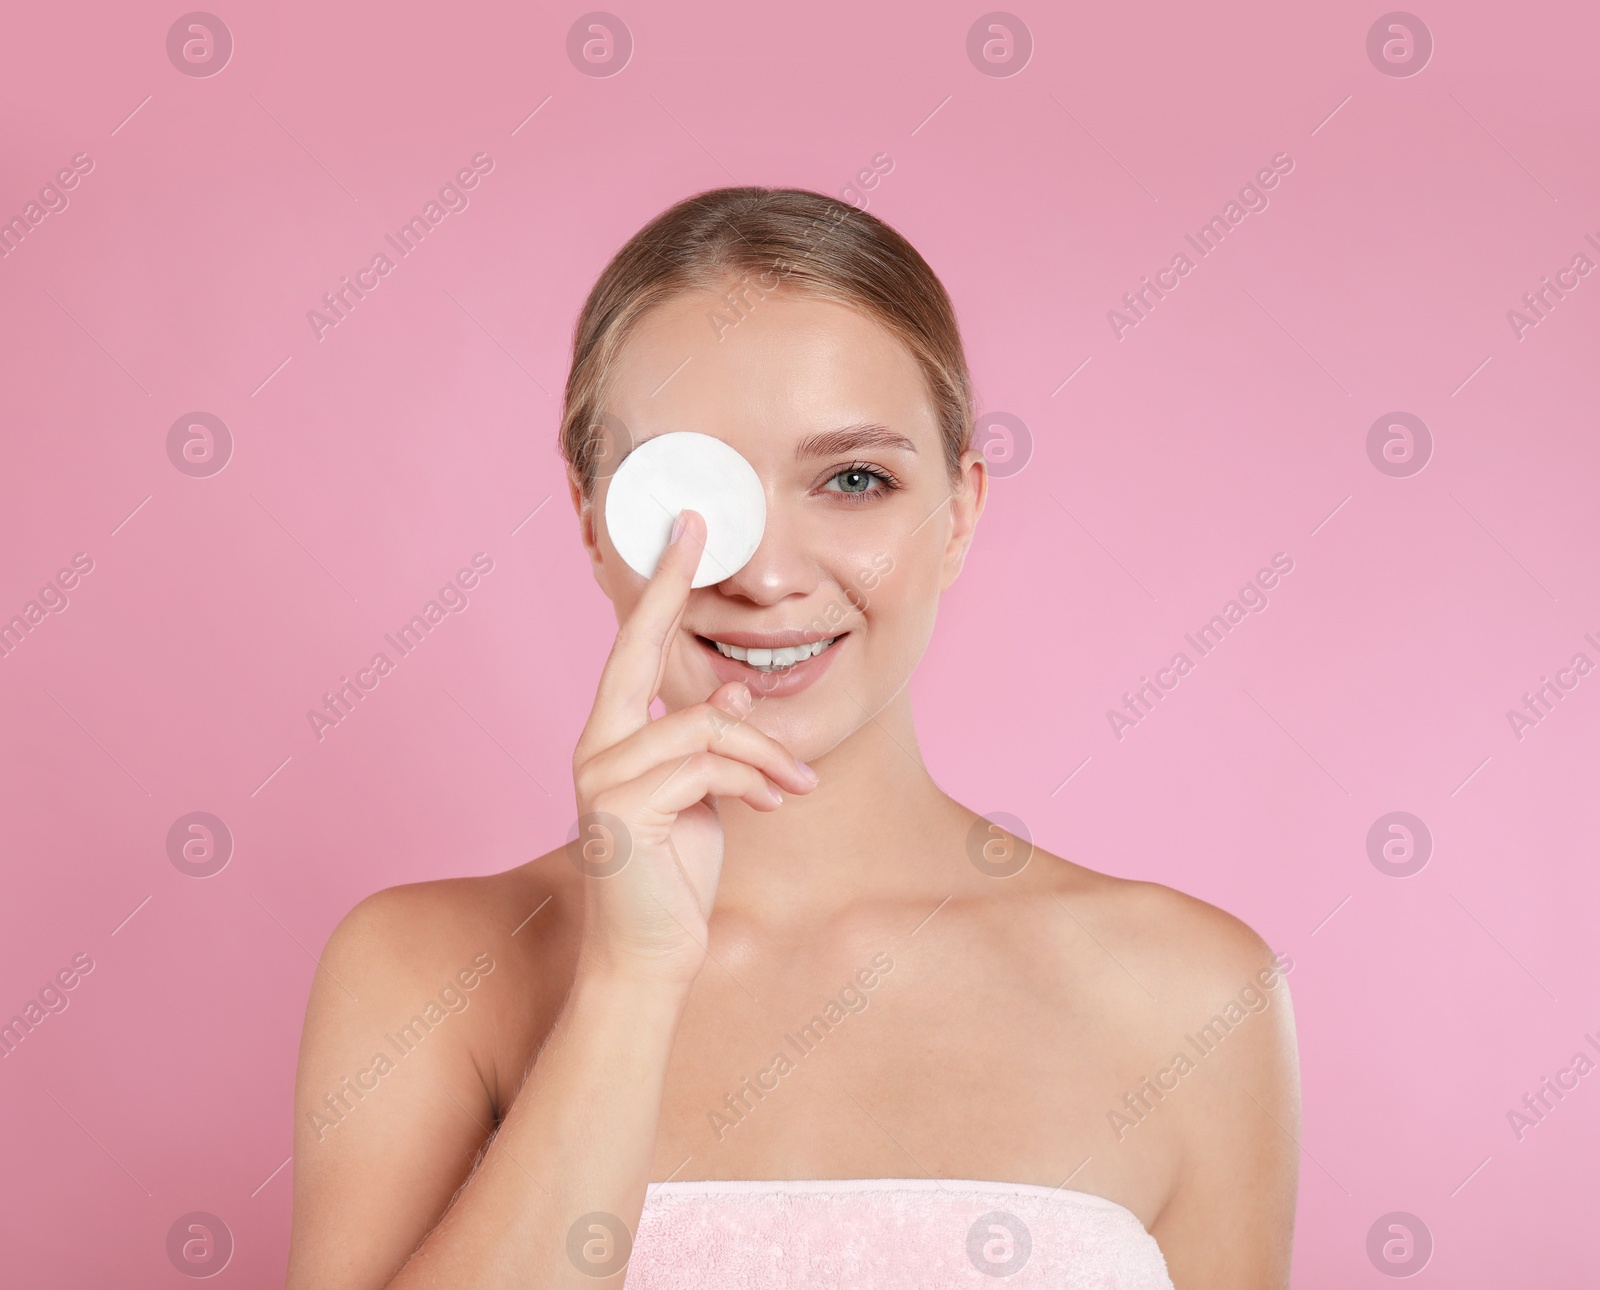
[560,187,973,496]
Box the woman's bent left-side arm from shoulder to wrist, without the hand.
[288,888,688,1290]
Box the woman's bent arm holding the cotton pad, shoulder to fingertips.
[288,512,816,1290]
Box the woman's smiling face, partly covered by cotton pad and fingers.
[573,291,987,760]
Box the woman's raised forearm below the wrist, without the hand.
[389,973,688,1290]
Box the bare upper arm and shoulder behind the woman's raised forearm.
[290,855,573,1287]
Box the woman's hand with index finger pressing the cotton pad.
[568,511,816,984]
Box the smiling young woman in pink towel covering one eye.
[288,187,1299,1290]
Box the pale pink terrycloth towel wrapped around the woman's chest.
[626,1178,1173,1290]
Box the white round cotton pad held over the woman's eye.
[605,431,766,587]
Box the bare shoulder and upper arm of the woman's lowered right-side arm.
[1024,861,1299,1287]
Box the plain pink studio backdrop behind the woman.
[0,0,1600,1287]
